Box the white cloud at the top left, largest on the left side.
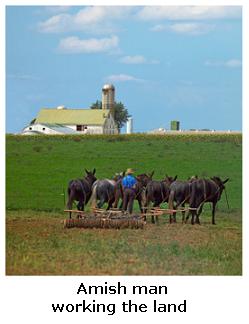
[38,6,132,33]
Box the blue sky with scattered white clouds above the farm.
[6,6,242,133]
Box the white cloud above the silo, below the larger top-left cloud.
[59,36,119,53]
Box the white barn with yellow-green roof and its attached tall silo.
[22,85,118,135]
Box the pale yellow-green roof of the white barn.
[35,108,109,125]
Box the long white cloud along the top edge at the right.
[137,6,242,21]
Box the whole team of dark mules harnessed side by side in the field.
[67,168,229,224]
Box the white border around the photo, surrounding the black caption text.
[0,0,249,324]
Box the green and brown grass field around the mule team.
[6,134,242,275]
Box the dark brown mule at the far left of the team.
[67,168,97,218]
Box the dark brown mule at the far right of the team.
[186,177,229,224]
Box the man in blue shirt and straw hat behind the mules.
[122,169,137,214]
